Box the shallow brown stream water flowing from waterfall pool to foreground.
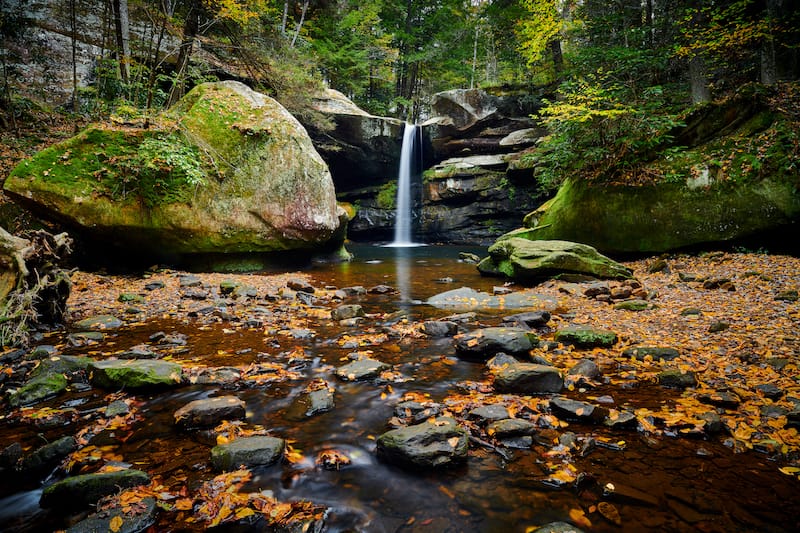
[0,246,800,532]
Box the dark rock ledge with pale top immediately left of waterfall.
[309,89,405,191]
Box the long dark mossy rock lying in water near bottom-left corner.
[39,468,150,512]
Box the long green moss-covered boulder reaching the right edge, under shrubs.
[523,175,800,252]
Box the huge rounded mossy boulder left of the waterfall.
[5,81,346,254]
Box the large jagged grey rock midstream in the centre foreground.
[377,417,469,469]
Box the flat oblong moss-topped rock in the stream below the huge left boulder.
[89,359,183,389]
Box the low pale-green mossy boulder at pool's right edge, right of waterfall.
[478,236,632,281]
